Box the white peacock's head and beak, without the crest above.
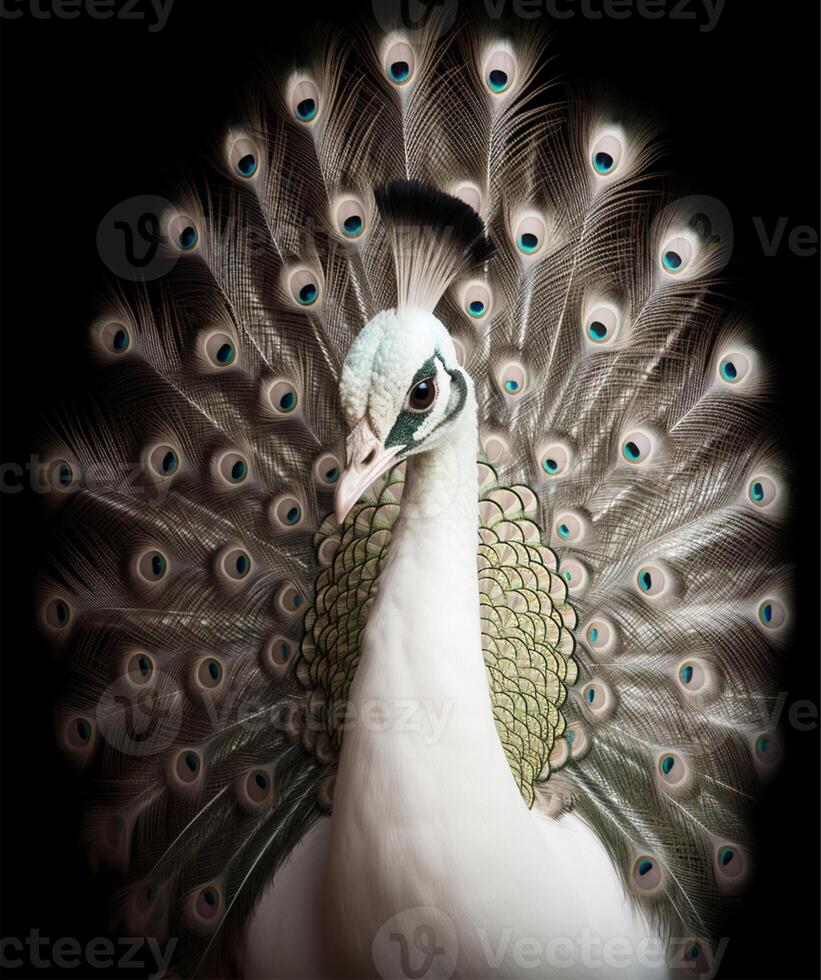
[335,309,473,523]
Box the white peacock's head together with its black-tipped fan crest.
[336,180,493,523]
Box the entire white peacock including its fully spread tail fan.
[41,11,791,977]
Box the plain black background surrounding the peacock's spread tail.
[0,0,819,978]
